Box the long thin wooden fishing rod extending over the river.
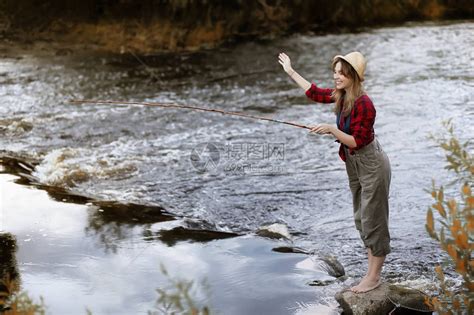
[69,100,312,130]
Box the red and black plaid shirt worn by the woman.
[306,83,375,161]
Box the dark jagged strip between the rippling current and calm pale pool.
[0,155,239,252]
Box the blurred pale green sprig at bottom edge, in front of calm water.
[148,265,210,315]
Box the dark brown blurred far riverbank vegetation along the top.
[0,0,474,52]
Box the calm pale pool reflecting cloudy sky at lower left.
[0,175,336,314]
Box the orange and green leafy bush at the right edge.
[426,121,474,314]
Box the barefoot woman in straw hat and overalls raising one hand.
[278,52,391,293]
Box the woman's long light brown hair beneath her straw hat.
[331,58,365,117]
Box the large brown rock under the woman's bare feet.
[336,283,431,315]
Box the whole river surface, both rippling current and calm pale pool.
[0,21,474,314]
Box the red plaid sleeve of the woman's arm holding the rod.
[350,95,376,150]
